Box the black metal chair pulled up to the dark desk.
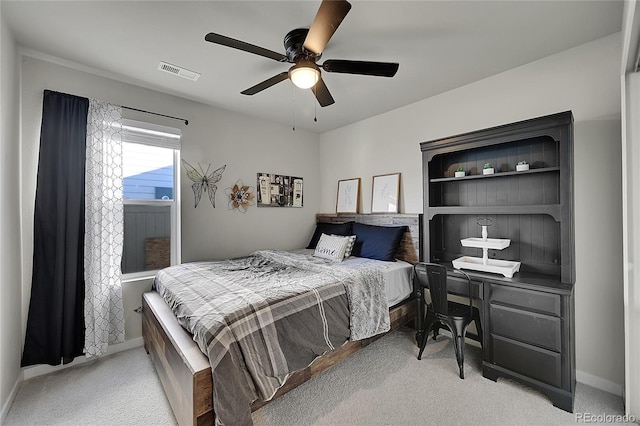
[414,262,482,379]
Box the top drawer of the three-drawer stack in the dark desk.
[489,284,562,317]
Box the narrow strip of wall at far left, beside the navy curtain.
[0,6,22,423]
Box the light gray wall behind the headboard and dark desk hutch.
[320,34,624,394]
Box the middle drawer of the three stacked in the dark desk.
[489,305,562,352]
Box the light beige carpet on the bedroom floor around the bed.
[5,328,624,426]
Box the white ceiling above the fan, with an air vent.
[1,0,623,133]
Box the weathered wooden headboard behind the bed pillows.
[316,213,422,263]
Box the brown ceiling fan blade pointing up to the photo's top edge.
[304,0,351,55]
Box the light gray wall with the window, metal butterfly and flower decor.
[18,57,320,347]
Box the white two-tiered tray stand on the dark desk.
[453,221,520,278]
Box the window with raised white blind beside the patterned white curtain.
[121,120,180,278]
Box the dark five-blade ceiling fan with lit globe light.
[204,0,398,107]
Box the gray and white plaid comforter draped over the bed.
[154,250,389,425]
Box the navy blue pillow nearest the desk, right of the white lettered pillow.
[351,223,407,262]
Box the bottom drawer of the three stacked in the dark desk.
[490,334,562,387]
